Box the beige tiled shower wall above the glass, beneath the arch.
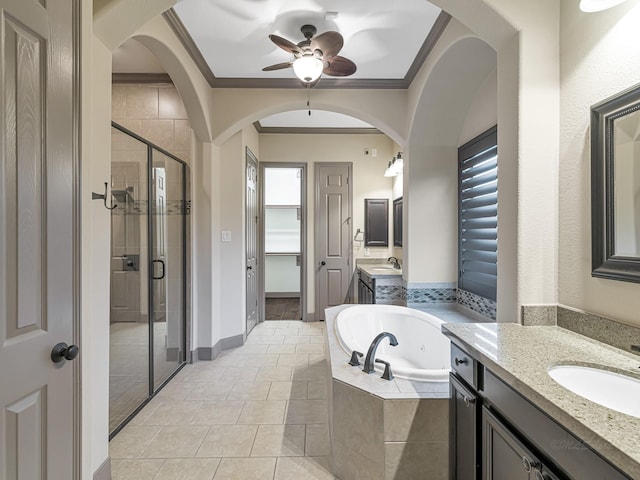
[111,83,191,165]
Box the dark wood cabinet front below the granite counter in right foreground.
[449,344,629,480]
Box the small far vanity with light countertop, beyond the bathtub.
[356,262,403,305]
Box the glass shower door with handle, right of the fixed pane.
[149,149,185,392]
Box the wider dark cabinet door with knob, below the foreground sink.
[482,407,560,480]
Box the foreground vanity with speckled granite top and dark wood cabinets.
[443,324,640,480]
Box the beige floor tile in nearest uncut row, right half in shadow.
[251,425,305,457]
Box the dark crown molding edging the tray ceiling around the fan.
[162,8,451,90]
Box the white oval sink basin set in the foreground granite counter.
[548,365,640,418]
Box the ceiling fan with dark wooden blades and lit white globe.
[262,25,357,87]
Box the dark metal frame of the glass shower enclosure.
[109,121,191,440]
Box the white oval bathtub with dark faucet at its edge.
[335,305,451,382]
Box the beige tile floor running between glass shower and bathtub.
[109,320,334,480]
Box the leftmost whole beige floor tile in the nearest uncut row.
[142,426,209,458]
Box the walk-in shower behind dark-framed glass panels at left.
[109,123,189,436]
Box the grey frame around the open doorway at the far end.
[258,162,314,322]
